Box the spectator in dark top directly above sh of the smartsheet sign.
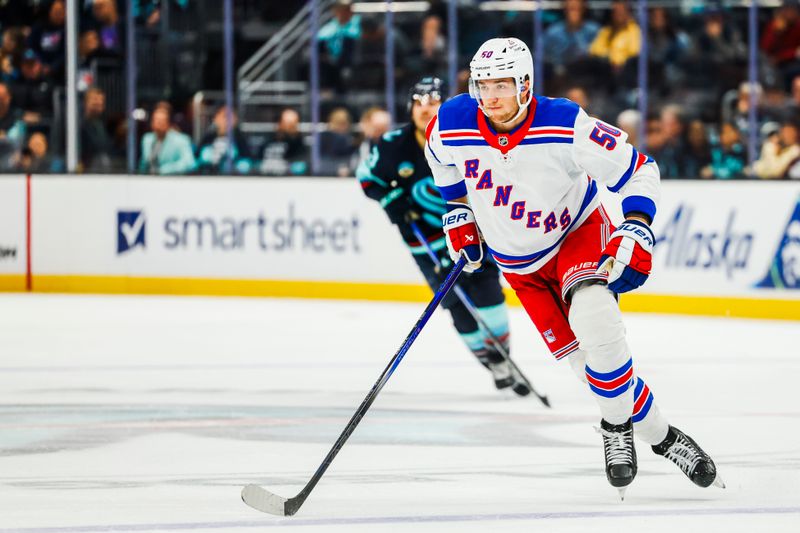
[261,108,308,176]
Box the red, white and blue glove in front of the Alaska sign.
[597,220,656,293]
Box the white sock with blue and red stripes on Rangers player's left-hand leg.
[569,285,634,424]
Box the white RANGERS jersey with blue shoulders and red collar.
[425,94,659,274]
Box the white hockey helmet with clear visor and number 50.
[469,37,533,122]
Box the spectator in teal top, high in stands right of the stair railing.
[317,0,361,92]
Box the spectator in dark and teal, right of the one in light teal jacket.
[197,106,253,174]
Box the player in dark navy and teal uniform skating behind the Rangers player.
[356,77,530,396]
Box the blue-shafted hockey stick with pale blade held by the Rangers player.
[242,257,467,516]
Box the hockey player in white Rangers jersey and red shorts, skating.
[425,38,724,495]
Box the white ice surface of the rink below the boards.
[0,294,800,533]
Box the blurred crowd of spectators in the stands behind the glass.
[0,0,800,179]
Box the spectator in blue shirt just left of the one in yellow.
[544,0,600,75]
